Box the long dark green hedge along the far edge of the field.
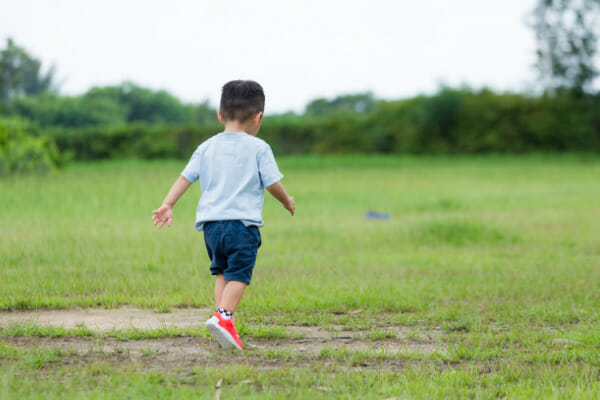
[45,88,600,160]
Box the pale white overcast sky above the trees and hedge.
[0,0,535,113]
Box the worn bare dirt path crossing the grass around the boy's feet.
[0,307,444,368]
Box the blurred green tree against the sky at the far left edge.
[0,38,55,102]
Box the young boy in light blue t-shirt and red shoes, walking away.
[152,80,295,350]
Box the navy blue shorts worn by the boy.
[204,220,261,284]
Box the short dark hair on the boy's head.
[220,80,265,122]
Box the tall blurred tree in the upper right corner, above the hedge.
[531,0,600,95]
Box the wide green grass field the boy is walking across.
[0,155,600,399]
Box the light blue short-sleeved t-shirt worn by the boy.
[181,132,283,231]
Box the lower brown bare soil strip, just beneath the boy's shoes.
[0,337,432,374]
